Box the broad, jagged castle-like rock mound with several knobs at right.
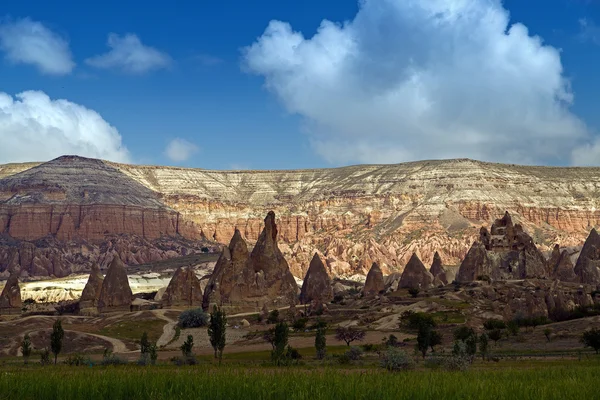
[457,212,552,282]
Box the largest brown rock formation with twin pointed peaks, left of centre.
[203,211,298,310]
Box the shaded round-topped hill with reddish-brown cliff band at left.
[0,156,211,277]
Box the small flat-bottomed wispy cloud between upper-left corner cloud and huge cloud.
[85,33,172,74]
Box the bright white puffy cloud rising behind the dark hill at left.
[0,91,130,163]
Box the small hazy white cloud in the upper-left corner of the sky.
[0,18,75,75]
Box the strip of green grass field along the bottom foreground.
[0,359,600,400]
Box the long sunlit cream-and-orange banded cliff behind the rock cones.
[0,159,600,278]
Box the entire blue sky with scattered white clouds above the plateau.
[0,0,600,169]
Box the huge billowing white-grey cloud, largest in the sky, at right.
[243,0,591,164]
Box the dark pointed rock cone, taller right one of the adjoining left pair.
[98,255,133,311]
